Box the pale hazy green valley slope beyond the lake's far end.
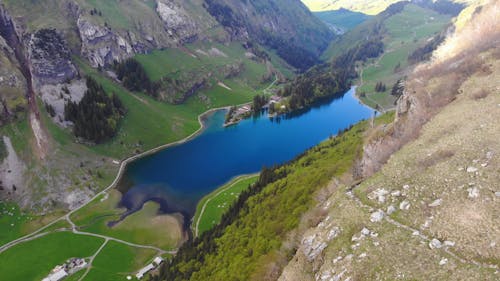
[323,4,451,110]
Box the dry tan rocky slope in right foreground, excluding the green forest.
[280,3,500,280]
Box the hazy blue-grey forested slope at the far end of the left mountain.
[207,0,332,70]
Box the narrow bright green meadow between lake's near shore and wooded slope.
[192,175,259,235]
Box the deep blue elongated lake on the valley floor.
[120,88,374,219]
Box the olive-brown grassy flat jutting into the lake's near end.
[71,190,183,250]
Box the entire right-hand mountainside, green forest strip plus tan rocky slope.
[153,1,500,281]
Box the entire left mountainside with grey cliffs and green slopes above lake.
[0,0,333,210]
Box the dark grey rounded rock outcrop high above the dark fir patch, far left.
[28,29,78,85]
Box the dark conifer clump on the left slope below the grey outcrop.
[64,77,126,143]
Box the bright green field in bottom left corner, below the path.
[0,232,104,281]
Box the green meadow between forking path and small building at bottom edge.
[83,238,156,281]
